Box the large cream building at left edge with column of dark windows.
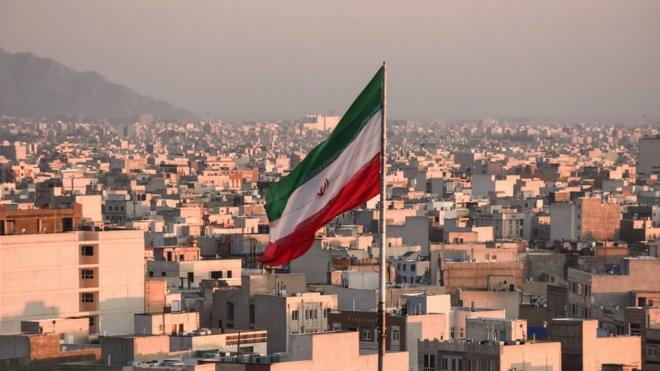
[0,230,144,334]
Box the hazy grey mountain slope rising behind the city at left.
[0,49,195,120]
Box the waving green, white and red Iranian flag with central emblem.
[260,68,385,266]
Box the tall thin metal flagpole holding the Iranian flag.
[378,62,387,371]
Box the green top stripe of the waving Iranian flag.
[266,67,384,223]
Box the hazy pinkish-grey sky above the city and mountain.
[0,0,660,120]
